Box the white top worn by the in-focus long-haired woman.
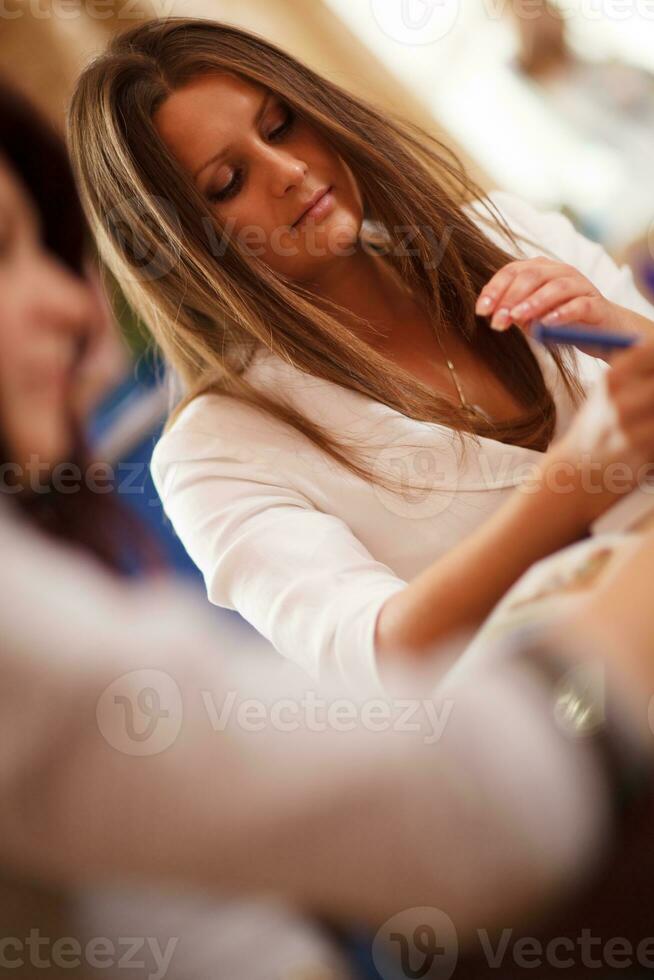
[151,191,654,682]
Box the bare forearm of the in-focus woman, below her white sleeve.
[375,451,606,660]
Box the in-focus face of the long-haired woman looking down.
[154,73,363,283]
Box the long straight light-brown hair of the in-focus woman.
[68,18,583,486]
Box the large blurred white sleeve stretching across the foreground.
[0,510,624,935]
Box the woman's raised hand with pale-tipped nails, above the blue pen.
[475,256,640,360]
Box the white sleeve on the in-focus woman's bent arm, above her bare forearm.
[151,429,406,688]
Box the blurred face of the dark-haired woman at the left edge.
[0,155,93,472]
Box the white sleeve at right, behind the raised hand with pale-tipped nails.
[488,190,654,321]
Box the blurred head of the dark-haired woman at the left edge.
[0,80,158,571]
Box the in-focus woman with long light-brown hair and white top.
[69,18,654,679]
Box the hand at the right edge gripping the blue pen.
[546,333,654,523]
